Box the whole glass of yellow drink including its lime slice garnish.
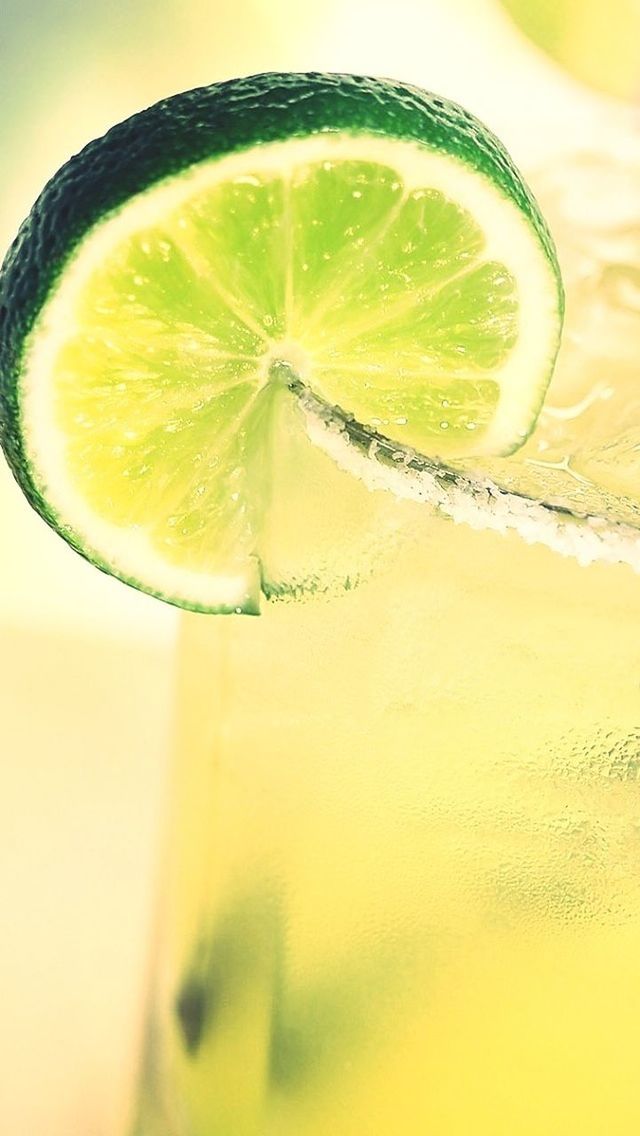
[0,75,640,1136]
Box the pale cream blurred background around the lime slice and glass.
[0,0,640,1136]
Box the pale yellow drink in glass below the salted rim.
[133,510,640,1136]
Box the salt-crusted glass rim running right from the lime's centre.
[300,390,640,575]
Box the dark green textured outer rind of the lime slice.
[0,73,563,611]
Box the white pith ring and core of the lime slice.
[20,133,558,607]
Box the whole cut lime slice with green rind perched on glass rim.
[0,75,563,611]
